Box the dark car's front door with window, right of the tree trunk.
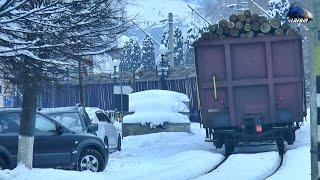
[34,114,74,168]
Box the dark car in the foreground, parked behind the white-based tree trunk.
[0,109,108,172]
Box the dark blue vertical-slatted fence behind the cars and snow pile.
[38,77,197,112]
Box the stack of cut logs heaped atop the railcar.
[201,10,297,40]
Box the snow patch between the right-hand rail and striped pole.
[268,146,311,180]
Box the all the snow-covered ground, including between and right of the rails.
[0,112,310,180]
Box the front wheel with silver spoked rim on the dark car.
[78,148,105,172]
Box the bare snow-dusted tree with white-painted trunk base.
[0,0,127,168]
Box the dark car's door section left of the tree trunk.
[0,112,20,165]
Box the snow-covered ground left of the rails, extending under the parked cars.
[0,124,224,180]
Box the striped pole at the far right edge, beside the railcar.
[308,0,320,180]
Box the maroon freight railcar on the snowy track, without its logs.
[194,35,306,155]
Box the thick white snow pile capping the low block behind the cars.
[123,90,190,127]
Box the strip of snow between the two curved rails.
[198,152,280,180]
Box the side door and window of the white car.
[96,111,118,148]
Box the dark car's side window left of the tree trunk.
[0,112,20,133]
